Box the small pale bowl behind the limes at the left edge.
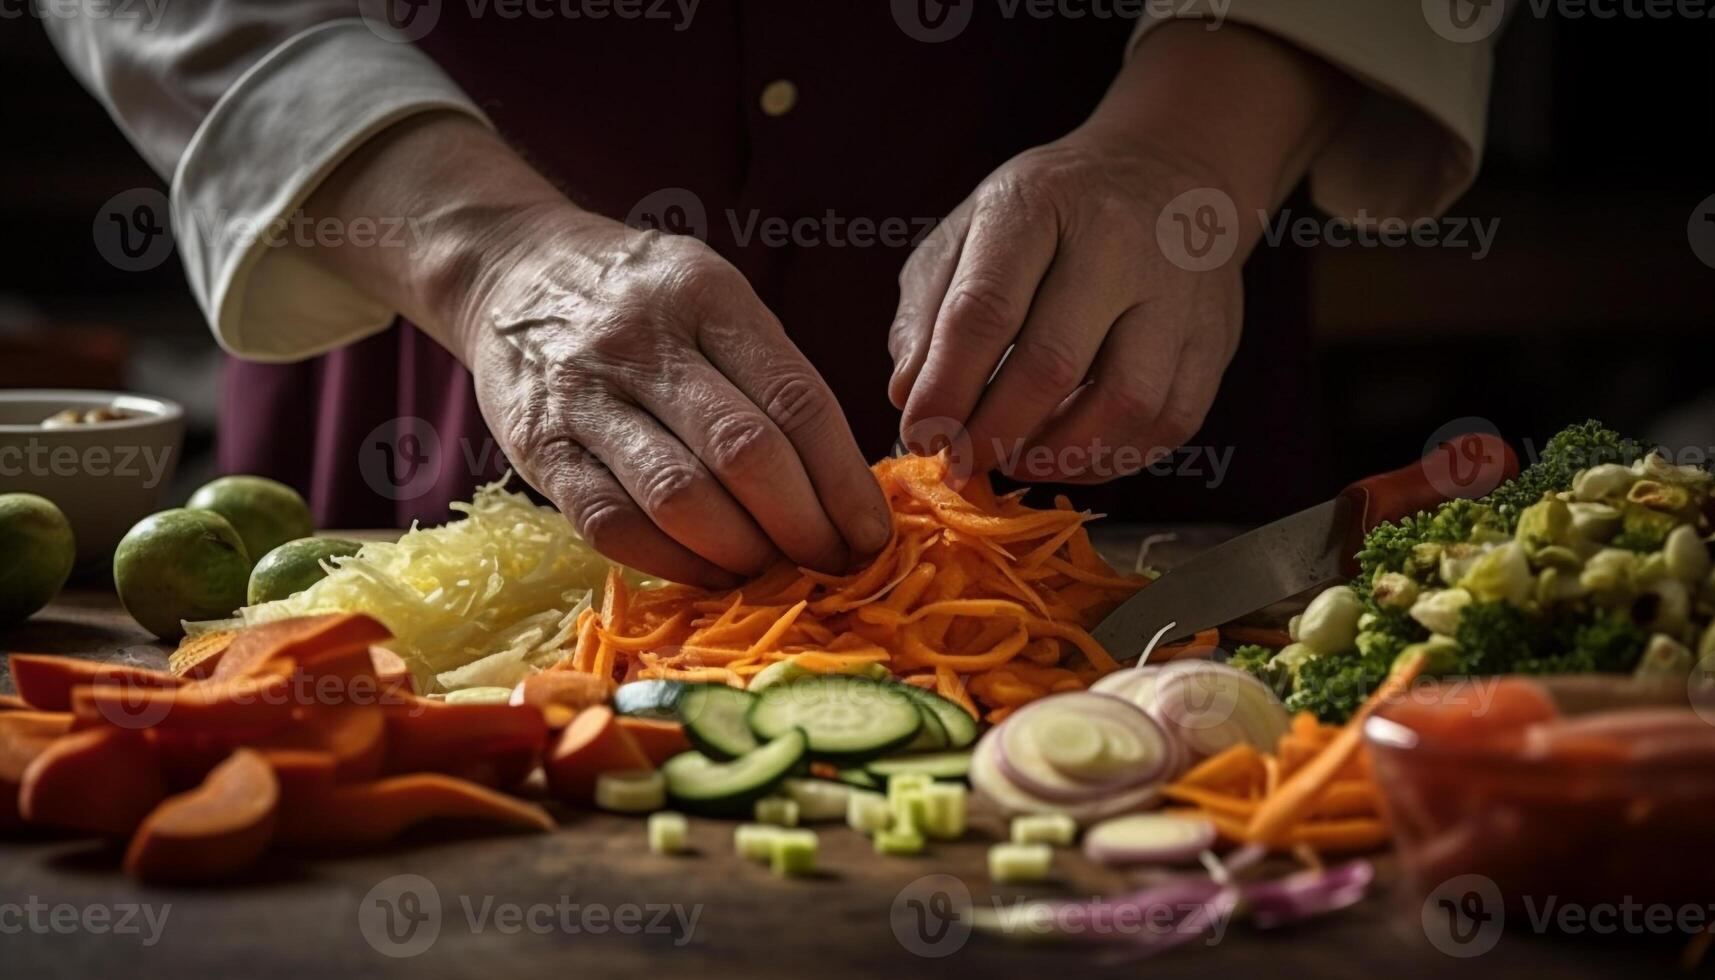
[0,390,185,570]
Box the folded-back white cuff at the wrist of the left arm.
[172,19,487,360]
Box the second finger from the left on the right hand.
[904,189,1058,448]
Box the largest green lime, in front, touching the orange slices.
[113,508,250,640]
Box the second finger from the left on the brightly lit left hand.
[573,402,773,575]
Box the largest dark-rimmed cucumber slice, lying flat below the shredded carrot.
[749,675,923,764]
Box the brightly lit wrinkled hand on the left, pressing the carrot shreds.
[456,206,888,585]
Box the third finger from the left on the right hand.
[969,251,1128,472]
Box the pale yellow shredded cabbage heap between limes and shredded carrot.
[202,474,617,693]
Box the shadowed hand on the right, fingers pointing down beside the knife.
[888,134,1242,482]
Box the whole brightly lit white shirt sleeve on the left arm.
[45,0,485,360]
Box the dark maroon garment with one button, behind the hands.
[220,0,1327,527]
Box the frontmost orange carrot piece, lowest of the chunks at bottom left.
[125,748,280,882]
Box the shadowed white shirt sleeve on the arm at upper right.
[1130,0,1501,220]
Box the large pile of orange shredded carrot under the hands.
[556,457,1138,721]
